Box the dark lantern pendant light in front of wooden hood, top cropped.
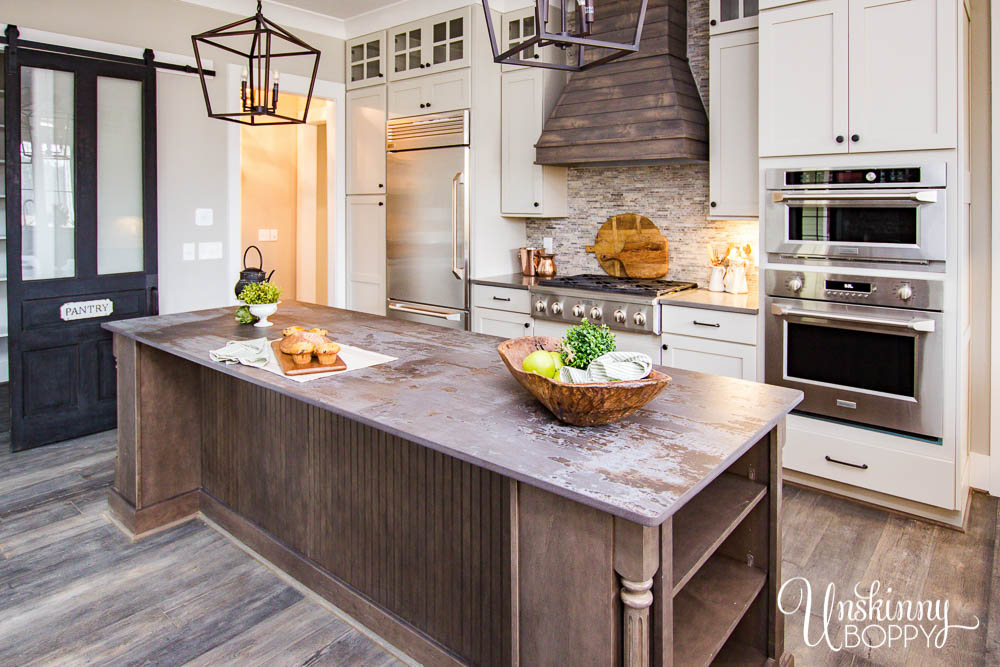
[483,0,648,72]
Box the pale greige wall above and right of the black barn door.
[0,0,344,313]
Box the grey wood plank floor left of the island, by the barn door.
[0,432,405,666]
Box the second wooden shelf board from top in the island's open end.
[673,555,767,666]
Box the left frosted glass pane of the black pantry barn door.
[20,67,76,280]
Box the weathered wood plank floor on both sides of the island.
[0,432,1000,666]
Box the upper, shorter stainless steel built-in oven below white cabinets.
[764,163,948,271]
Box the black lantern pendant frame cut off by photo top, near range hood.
[483,0,648,72]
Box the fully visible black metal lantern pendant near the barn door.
[191,0,320,125]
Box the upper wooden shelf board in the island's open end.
[672,473,767,595]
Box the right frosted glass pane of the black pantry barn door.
[97,76,142,275]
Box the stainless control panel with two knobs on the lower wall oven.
[764,270,944,310]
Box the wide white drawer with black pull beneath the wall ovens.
[782,415,956,509]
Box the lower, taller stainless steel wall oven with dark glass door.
[765,272,945,440]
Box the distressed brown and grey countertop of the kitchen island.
[104,301,802,526]
